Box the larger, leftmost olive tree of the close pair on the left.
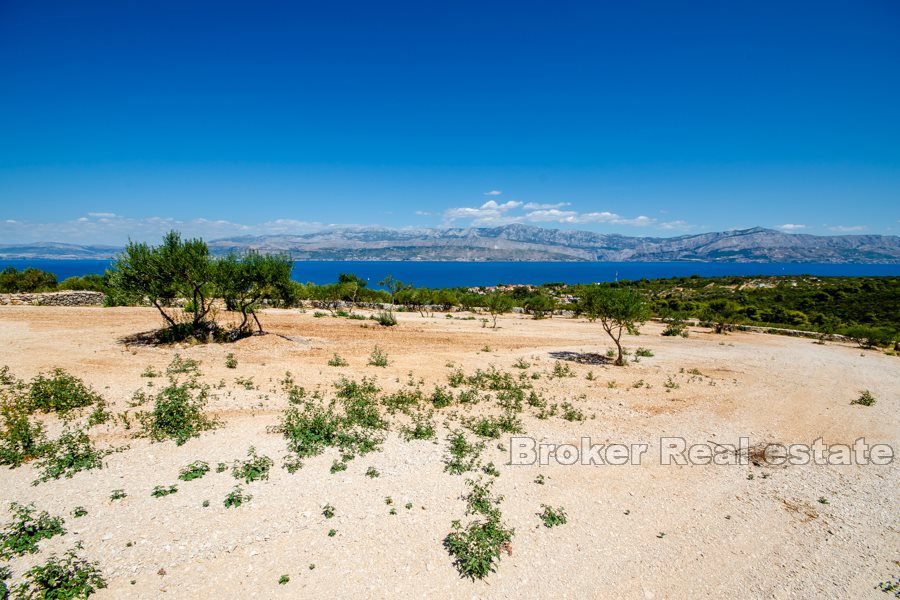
[110,231,215,333]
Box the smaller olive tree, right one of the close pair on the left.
[216,250,293,333]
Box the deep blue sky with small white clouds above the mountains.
[0,0,900,243]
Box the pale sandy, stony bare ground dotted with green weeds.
[0,306,900,598]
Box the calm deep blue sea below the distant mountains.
[0,260,900,287]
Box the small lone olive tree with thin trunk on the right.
[579,286,650,366]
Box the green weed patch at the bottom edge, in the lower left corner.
[15,542,106,599]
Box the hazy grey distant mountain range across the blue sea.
[0,225,900,263]
